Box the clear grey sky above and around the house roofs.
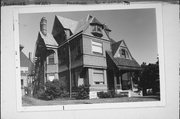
[19,8,158,64]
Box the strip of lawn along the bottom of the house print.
[22,96,160,106]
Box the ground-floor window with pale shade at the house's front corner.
[93,69,104,84]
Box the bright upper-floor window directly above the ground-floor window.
[92,41,103,54]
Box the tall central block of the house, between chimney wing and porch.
[52,15,111,97]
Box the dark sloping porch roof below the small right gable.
[107,51,141,70]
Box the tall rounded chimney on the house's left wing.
[40,17,47,36]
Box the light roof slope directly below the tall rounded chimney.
[39,32,58,47]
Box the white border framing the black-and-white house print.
[13,3,166,111]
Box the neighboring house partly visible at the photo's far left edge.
[20,45,33,95]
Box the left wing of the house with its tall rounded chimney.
[33,17,59,94]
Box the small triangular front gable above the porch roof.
[114,40,133,60]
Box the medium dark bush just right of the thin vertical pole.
[75,85,89,99]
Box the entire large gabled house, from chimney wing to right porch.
[35,15,140,98]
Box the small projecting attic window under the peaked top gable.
[91,25,103,37]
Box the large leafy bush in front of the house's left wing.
[37,79,68,100]
